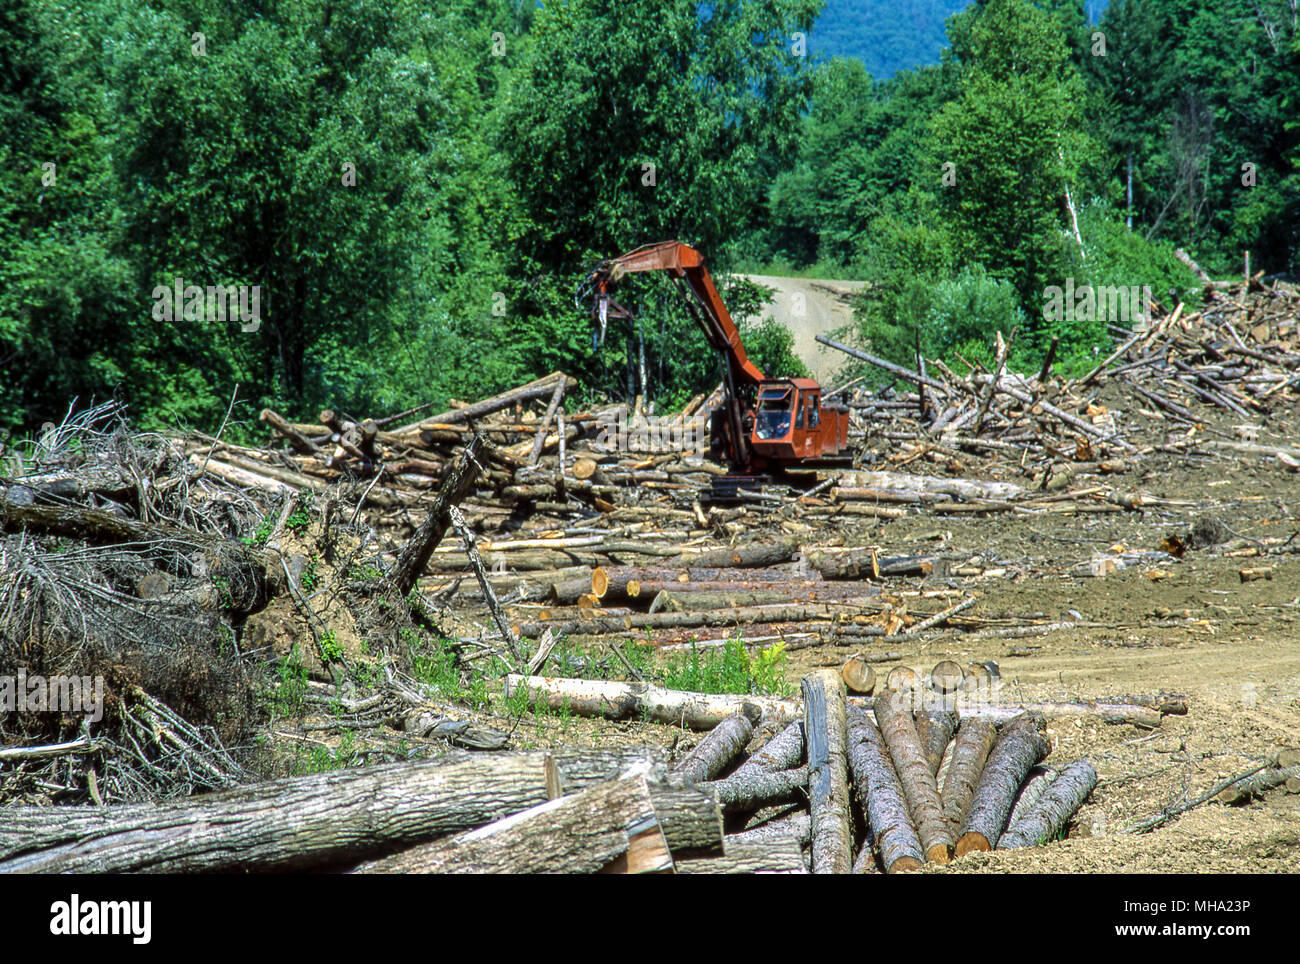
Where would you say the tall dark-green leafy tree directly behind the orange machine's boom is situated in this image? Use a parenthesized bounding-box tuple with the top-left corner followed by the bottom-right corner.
(499, 0, 819, 405)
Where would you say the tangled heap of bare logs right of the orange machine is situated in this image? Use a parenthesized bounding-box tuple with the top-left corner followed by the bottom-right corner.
(818, 275, 1300, 485)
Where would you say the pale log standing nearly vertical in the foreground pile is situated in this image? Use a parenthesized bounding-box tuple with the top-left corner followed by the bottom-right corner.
(801, 669, 853, 873)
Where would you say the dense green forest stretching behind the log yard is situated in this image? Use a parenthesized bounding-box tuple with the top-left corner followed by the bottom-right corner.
(0, 0, 1300, 439)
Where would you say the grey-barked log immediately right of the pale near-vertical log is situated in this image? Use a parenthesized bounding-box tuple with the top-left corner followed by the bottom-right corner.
(849, 708, 924, 873)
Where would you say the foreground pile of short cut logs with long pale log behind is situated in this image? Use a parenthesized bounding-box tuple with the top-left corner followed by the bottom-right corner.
(501, 670, 1097, 873)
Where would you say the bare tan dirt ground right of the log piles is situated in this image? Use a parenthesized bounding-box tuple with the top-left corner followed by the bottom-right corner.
(496, 456, 1300, 873)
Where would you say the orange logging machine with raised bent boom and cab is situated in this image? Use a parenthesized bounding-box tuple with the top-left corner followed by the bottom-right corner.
(575, 242, 850, 496)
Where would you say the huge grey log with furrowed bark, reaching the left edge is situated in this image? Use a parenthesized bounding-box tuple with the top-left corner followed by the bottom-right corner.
(0, 752, 554, 873)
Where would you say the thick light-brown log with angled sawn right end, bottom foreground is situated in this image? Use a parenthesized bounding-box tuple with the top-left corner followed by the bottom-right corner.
(356, 774, 672, 873)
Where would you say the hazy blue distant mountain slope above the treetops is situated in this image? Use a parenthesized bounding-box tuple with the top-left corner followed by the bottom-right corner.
(809, 0, 967, 81)
